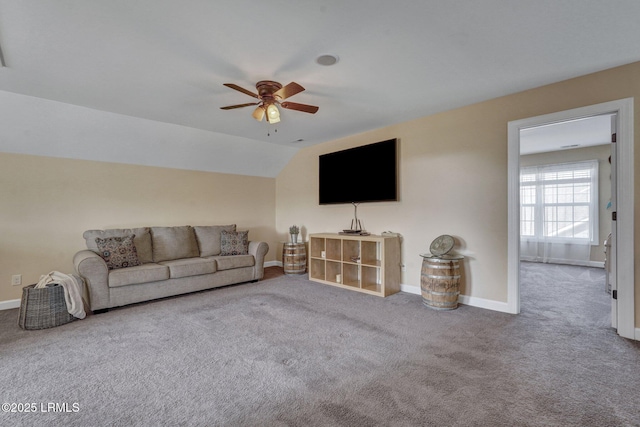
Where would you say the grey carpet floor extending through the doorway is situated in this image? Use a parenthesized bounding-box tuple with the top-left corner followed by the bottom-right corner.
(0, 263, 640, 426)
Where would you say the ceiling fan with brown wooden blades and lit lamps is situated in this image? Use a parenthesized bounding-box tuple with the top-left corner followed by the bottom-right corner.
(220, 80, 318, 124)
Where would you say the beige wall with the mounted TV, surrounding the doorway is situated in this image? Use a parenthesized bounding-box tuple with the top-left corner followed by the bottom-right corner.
(276, 63, 640, 324)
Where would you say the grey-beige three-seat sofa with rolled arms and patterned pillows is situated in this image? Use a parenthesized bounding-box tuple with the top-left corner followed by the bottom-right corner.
(73, 224, 269, 311)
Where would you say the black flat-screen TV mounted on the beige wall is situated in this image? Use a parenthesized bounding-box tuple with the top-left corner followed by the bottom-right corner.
(319, 139, 398, 205)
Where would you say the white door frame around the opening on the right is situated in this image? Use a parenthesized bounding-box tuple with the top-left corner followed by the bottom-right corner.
(507, 98, 640, 340)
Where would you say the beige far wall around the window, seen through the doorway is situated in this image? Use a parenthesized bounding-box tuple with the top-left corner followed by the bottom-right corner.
(520, 145, 611, 262)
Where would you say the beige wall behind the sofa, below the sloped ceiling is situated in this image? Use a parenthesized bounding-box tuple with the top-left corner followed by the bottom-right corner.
(0, 153, 277, 302)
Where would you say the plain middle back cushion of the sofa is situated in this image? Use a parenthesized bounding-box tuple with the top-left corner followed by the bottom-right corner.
(151, 225, 199, 262)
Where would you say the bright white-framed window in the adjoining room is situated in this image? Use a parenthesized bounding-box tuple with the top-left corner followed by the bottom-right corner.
(520, 160, 598, 244)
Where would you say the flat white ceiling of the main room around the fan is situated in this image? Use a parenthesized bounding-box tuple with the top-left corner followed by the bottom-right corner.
(0, 0, 640, 173)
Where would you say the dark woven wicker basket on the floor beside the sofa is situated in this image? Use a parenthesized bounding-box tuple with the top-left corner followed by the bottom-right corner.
(18, 284, 75, 330)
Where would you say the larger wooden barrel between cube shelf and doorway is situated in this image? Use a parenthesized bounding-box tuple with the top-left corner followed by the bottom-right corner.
(420, 255, 463, 310)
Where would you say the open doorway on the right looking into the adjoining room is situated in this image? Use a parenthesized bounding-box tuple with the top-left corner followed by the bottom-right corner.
(519, 114, 617, 324)
